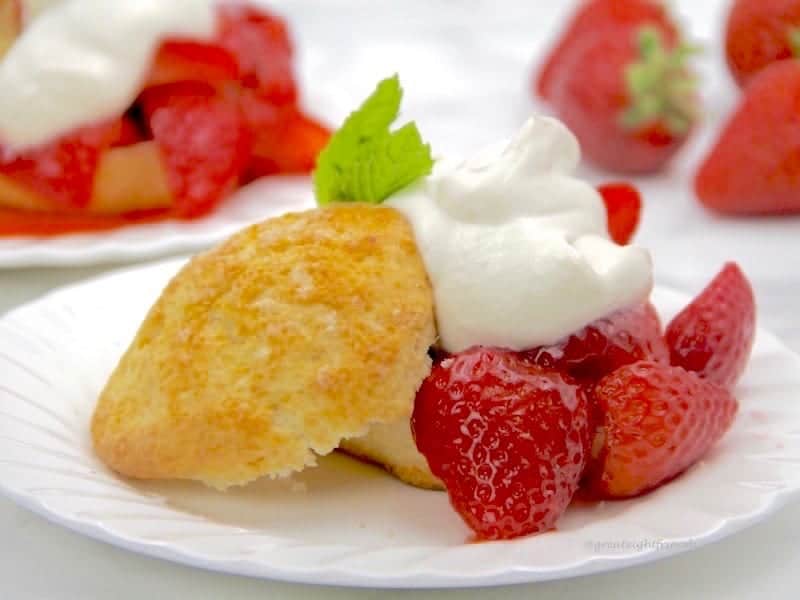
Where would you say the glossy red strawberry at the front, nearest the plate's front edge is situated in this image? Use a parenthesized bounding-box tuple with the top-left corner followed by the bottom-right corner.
(411, 348, 589, 540)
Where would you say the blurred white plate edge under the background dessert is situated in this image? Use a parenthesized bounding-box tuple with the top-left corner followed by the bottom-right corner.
(0, 176, 314, 269)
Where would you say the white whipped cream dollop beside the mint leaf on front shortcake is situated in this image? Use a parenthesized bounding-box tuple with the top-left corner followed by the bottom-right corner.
(387, 117, 653, 352)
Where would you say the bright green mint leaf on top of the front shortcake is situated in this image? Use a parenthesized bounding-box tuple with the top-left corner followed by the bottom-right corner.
(314, 75, 433, 206)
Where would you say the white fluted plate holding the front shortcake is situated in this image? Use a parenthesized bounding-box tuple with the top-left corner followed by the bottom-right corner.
(0, 261, 800, 587)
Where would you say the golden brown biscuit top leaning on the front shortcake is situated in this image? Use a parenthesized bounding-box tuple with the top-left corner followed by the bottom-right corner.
(92, 204, 435, 488)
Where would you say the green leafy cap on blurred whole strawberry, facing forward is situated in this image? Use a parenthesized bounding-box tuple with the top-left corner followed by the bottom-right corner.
(621, 27, 698, 135)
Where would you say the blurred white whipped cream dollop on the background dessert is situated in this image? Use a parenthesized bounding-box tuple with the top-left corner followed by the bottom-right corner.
(0, 0, 216, 151)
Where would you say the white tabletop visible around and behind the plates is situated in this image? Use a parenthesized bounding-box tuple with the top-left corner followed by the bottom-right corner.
(0, 0, 800, 600)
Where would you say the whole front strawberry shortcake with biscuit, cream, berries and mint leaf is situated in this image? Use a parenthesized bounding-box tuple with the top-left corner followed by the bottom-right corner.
(91, 78, 755, 540)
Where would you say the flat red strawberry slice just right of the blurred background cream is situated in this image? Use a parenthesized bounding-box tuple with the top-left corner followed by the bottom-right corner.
(144, 40, 239, 88)
